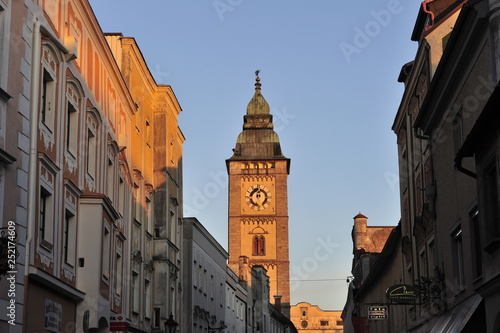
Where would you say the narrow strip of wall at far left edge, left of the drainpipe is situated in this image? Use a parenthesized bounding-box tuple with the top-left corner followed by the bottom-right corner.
(0, 1, 31, 332)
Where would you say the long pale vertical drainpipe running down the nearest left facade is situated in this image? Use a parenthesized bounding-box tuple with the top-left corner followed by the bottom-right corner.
(24, 17, 42, 277)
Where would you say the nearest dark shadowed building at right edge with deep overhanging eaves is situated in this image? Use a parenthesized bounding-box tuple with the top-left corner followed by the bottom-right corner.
(414, 1, 500, 332)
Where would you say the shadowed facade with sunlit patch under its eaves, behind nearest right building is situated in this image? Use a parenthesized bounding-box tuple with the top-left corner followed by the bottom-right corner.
(393, 4, 471, 329)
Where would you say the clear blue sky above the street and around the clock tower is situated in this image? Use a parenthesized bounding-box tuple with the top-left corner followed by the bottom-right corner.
(90, 0, 420, 310)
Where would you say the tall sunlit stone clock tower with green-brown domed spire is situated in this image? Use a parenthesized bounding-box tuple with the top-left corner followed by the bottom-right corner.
(226, 71, 290, 316)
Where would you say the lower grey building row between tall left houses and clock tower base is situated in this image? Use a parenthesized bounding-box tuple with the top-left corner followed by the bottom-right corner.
(185, 217, 296, 333)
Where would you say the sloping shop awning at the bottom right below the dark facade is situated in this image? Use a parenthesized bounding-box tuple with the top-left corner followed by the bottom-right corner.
(431, 294, 482, 333)
